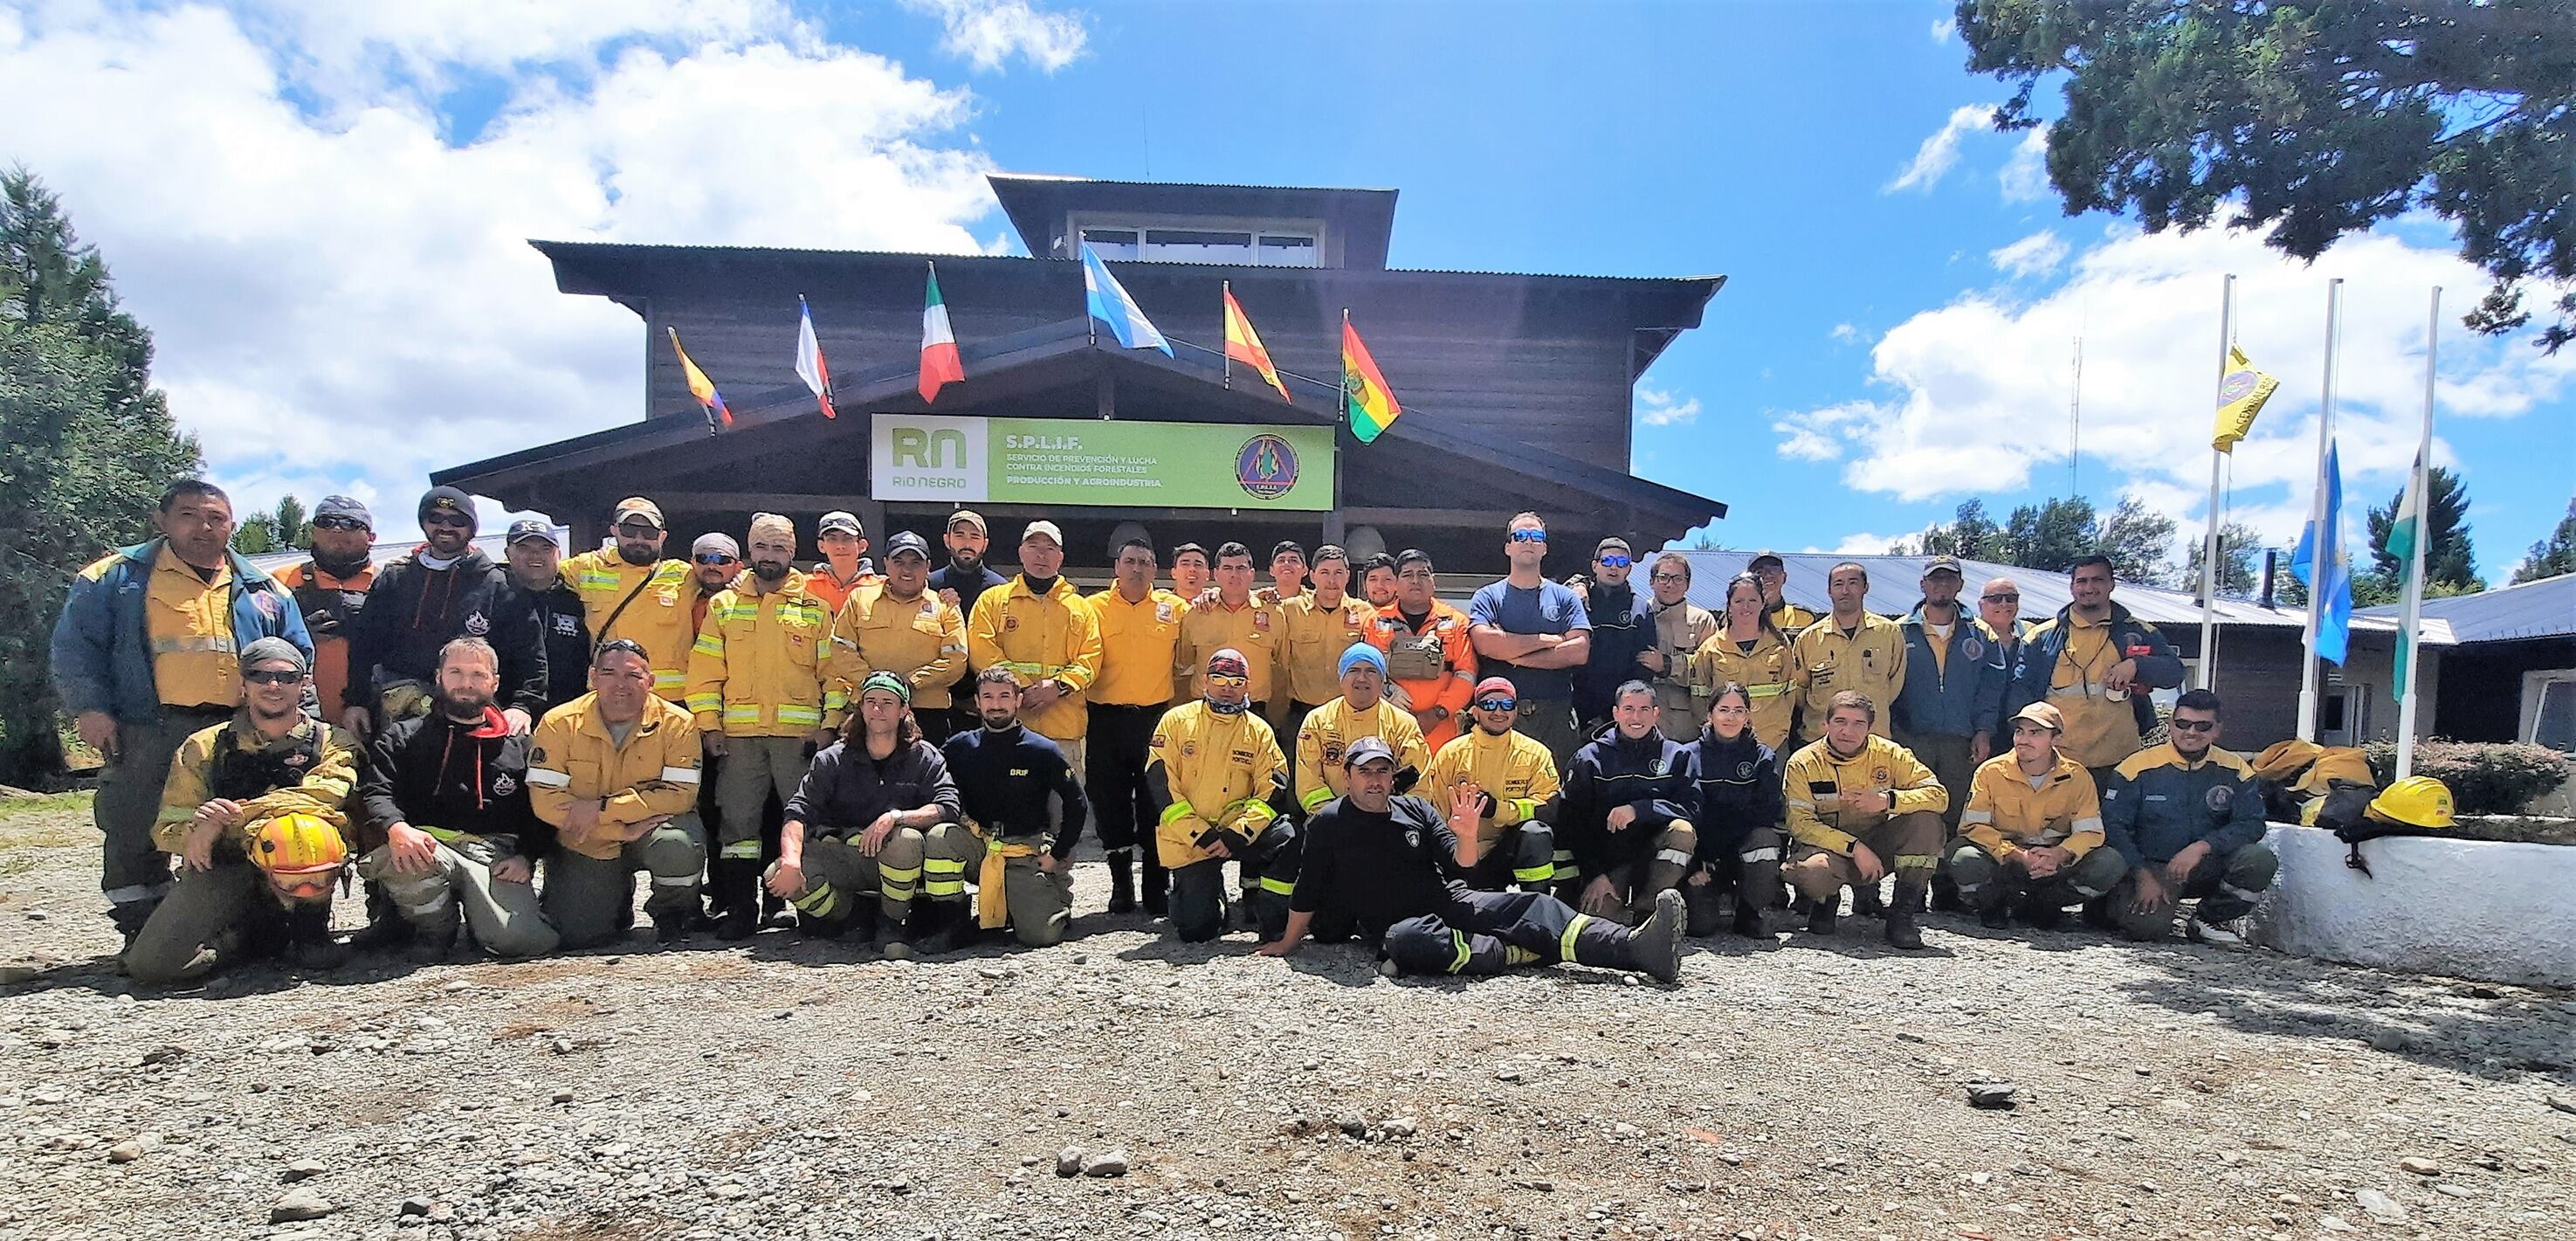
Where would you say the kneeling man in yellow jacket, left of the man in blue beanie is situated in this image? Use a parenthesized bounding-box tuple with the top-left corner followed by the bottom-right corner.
(1144, 646, 1301, 942)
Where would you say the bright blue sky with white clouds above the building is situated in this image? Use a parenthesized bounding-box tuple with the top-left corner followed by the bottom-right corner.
(0, 0, 2576, 584)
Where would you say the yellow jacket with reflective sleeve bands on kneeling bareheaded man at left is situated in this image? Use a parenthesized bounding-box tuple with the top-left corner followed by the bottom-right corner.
(528, 693, 698, 860)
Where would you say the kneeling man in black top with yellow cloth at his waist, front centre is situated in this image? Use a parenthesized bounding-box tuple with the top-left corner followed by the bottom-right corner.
(922, 667, 1082, 953)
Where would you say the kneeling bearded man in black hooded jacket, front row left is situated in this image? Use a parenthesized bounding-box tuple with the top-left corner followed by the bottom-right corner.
(358, 641, 556, 963)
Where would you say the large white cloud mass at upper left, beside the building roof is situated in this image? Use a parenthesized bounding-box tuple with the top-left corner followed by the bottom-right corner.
(0, 0, 1025, 533)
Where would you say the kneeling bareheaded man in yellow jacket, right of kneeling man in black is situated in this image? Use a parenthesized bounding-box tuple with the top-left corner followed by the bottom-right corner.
(528, 638, 706, 948)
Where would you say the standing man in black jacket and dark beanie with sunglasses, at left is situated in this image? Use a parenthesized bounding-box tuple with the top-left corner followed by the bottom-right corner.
(342, 486, 546, 736)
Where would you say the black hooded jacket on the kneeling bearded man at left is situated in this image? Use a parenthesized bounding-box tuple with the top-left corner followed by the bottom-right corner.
(358, 708, 554, 858)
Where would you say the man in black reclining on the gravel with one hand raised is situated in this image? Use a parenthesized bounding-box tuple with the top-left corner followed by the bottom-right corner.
(1260, 736, 1684, 983)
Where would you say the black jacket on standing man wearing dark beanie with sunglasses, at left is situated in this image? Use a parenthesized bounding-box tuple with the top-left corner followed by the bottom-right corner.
(348, 548, 546, 716)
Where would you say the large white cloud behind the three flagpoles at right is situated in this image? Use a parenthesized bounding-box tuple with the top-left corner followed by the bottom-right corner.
(1773, 226, 2576, 541)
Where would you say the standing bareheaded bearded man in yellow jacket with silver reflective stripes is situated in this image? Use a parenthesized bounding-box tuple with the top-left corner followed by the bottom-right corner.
(688, 513, 851, 940)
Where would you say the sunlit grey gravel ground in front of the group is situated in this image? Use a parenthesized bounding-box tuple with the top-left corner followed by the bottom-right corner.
(0, 803, 2576, 1241)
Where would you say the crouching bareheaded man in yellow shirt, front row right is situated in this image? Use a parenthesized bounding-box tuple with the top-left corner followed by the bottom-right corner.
(1780, 690, 1950, 948)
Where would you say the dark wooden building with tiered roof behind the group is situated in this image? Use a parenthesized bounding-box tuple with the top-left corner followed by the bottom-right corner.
(436, 175, 1726, 574)
